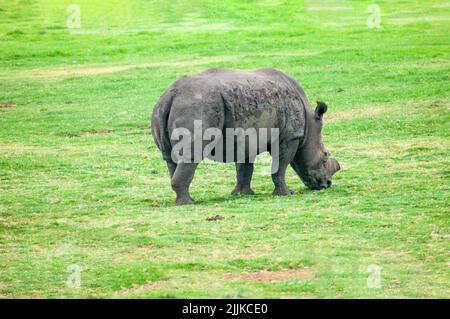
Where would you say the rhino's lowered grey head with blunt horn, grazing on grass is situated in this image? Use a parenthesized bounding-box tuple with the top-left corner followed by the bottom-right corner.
(290, 102, 341, 189)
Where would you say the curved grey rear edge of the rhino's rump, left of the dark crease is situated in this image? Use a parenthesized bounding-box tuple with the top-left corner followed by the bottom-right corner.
(151, 89, 175, 160)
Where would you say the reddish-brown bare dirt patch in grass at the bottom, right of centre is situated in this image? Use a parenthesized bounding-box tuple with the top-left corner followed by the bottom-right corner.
(239, 268, 314, 282)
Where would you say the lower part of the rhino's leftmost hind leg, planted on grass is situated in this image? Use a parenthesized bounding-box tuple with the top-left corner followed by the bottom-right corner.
(171, 163, 198, 205)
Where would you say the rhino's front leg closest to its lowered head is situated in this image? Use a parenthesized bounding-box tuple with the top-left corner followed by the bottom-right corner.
(272, 139, 299, 196)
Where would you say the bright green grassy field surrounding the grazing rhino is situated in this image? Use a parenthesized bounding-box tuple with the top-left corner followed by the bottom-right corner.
(0, 0, 450, 298)
